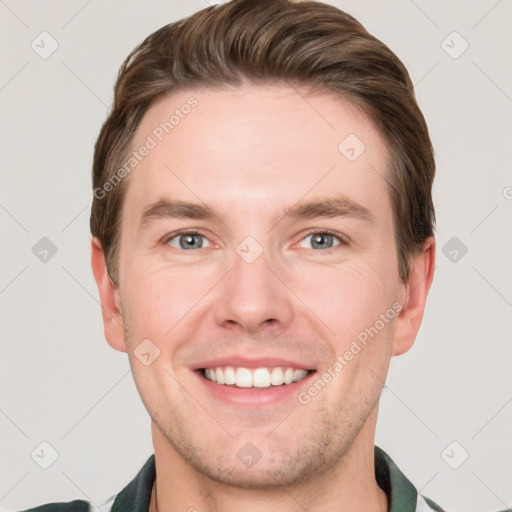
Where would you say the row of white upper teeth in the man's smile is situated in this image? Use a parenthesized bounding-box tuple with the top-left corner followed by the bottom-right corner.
(204, 366, 308, 388)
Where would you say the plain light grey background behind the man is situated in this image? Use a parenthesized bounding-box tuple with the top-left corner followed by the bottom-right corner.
(0, 0, 512, 512)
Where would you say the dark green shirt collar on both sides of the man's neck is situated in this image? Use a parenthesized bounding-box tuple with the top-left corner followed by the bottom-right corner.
(111, 446, 440, 512)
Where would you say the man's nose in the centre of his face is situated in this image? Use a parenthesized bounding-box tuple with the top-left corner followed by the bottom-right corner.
(215, 244, 293, 334)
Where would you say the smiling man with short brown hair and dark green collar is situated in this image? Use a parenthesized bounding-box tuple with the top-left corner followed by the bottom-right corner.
(21, 0, 452, 512)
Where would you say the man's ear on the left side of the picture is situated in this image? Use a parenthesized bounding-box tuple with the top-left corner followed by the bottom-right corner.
(91, 237, 126, 352)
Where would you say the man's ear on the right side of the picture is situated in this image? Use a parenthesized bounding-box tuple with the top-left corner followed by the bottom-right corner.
(392, 237, 436, 356)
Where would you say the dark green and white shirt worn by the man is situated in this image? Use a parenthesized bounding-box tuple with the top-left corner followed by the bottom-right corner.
(15, 446, 443, 512)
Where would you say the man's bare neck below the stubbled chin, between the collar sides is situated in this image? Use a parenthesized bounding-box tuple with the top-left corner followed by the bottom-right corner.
(150, 417, 388, 512)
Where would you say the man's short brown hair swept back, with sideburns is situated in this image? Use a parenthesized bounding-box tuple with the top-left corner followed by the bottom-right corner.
(91, 0, 435, 285)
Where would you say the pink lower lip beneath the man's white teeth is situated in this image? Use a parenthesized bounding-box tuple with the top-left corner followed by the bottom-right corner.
(194, 371, 315, 406)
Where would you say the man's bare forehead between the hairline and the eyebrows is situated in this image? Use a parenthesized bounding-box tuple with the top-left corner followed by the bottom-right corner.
(125, 85, 388, 220)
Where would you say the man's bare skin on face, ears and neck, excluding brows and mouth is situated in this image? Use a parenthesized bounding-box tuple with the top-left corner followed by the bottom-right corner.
(92, 84, 435, 512)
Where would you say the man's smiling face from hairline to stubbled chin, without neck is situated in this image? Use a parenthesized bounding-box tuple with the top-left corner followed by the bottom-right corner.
(93, 86, 432, 486)
